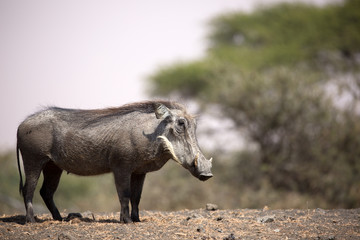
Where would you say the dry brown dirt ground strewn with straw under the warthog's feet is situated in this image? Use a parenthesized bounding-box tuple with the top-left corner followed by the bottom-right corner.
(0, 209, 360, 240)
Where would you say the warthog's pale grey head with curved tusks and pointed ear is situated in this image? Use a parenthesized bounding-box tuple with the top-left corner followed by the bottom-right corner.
(155, 104, 213, 181)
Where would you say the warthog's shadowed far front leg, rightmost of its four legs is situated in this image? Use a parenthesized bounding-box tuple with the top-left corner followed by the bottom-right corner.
(130, 173, 145, 222)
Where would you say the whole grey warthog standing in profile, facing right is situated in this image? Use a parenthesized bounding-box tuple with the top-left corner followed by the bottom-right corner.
(17, 101, 212, 223)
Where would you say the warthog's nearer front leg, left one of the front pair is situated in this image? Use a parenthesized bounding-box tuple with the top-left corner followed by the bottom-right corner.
(114, 171, 132, 223)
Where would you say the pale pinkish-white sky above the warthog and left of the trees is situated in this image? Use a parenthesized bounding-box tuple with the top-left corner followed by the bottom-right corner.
(0, 0, 329, 149)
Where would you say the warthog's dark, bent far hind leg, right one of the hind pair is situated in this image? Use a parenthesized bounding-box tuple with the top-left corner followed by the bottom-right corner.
(40, 161, 62, 221)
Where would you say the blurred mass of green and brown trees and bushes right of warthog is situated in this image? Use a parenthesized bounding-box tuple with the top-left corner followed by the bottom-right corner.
(150, 0, 360, 207)
